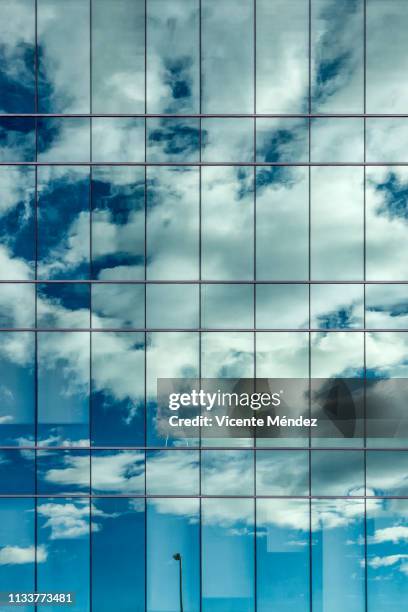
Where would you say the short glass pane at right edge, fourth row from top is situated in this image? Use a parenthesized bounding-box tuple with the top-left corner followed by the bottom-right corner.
(366, 283, 408, 329)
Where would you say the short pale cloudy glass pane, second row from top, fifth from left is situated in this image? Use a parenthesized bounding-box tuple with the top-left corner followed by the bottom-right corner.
(201, 119, 254, 163)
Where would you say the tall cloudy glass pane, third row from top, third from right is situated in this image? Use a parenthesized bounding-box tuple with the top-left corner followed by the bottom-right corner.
(256, 166, 309, 281)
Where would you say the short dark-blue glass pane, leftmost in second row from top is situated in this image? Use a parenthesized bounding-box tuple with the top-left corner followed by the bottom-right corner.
(0, 117, 36, 163)
